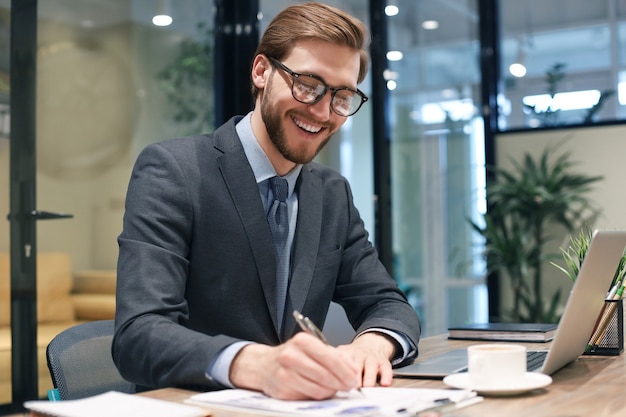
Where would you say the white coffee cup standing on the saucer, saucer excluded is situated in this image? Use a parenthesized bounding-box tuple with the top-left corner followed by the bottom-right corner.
(467, 343, 526, 388)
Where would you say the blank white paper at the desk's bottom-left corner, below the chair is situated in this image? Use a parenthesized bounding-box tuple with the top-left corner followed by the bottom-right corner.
(24, 391, 211, 417)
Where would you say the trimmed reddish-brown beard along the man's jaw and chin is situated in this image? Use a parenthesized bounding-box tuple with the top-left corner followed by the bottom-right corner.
(261, 79, 332, 164)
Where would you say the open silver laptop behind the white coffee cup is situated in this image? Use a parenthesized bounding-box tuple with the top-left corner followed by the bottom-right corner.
(394, 230, 626, 378)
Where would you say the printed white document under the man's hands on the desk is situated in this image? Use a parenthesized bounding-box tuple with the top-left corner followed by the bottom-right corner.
(187, 387, 482, 417)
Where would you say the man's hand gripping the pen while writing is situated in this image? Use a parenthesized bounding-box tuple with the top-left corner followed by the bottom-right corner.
(230, 332, 358, 400)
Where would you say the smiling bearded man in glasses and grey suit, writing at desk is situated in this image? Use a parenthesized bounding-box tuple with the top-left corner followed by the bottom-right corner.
(113, 3, 420, 399)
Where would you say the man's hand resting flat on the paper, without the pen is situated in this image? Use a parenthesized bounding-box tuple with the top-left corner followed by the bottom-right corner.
(338, 332, 396, 387)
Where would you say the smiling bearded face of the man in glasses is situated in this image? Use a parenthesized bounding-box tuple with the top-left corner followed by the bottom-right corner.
(255, 40, 359, 165)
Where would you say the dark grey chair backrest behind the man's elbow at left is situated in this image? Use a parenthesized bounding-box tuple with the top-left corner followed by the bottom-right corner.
(46, 320, 136, 400)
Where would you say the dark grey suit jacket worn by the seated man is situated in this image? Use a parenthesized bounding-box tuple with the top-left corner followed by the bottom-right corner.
(112, 118, 420, 389)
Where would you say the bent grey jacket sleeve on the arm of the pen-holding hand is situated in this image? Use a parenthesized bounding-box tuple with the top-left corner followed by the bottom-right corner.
(112, 144, 238, 388)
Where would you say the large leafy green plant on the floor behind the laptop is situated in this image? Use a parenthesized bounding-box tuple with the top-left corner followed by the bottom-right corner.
(469, 147, 602, 323)
